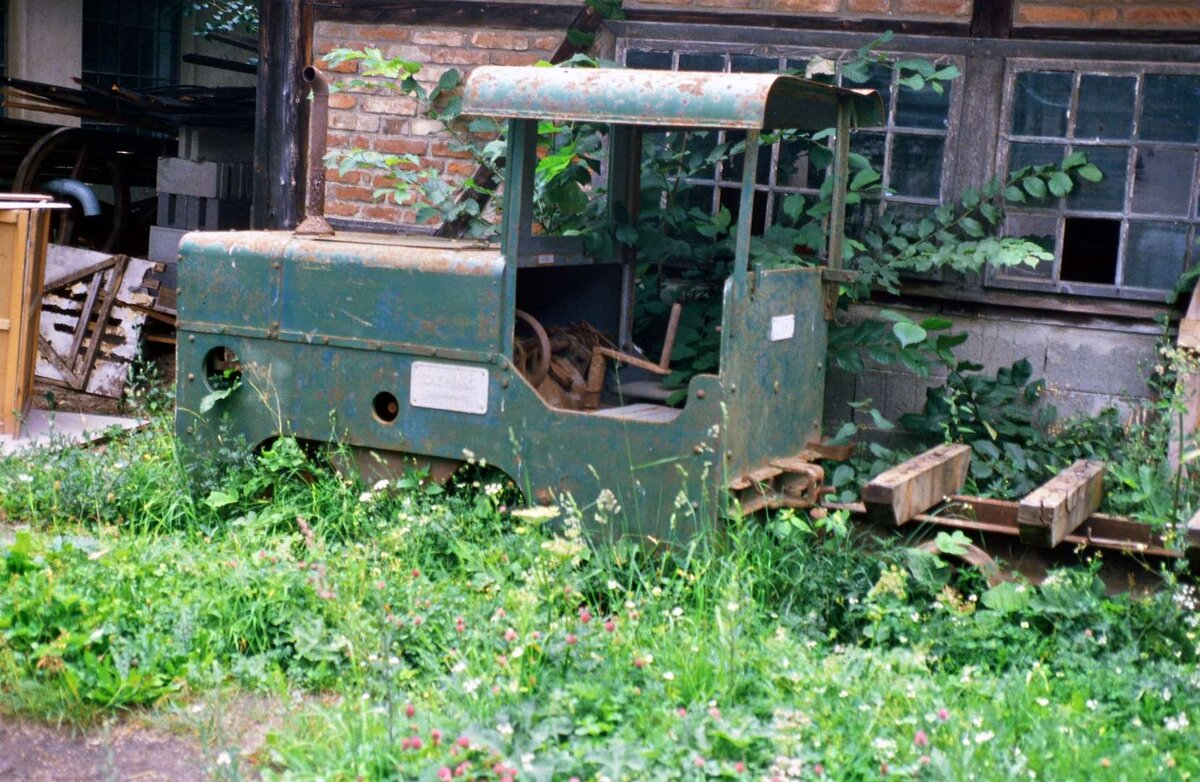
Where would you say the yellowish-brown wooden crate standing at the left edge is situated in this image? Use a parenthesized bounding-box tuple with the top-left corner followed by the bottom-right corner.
(0, 205, 50, 437)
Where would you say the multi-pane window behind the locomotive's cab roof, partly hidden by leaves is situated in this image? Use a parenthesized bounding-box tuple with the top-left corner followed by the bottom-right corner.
(624, 46, 962, 233)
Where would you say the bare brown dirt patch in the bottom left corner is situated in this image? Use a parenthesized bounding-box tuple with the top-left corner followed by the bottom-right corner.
(0, 715, 209, 782)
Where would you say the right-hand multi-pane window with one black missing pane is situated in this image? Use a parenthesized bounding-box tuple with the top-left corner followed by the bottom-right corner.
(990, 61, 1200, 299)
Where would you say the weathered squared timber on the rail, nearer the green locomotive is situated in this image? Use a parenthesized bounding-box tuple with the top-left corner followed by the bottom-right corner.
(863, 445, 971, 527)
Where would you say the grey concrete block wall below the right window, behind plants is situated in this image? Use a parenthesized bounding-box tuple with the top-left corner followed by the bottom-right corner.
(826, 305, 1160, 432)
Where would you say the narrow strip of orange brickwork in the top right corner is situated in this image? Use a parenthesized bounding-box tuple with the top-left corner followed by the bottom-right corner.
(1013, 0, 1200, 30)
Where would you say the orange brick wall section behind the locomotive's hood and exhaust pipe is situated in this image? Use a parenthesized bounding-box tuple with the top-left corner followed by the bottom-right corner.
(313, 22, 562, 223)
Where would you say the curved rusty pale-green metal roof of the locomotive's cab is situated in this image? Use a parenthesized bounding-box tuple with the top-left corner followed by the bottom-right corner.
(463, 66, 883, 131)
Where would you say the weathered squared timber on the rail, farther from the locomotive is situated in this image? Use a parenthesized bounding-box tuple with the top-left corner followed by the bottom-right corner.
(1016, 459, 1104, 548)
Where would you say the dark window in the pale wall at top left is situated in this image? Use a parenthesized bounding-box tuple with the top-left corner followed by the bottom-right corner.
(83, 0, 180, 90)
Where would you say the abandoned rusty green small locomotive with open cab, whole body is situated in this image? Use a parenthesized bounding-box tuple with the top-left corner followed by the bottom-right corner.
(176, 67, 882, 540)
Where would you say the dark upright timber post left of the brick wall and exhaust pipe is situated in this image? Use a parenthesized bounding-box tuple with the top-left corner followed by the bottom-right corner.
(252, 0, 308, 229)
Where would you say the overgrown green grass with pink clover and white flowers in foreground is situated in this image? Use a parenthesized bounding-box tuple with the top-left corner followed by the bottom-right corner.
(0, 421, 1200, 780)
